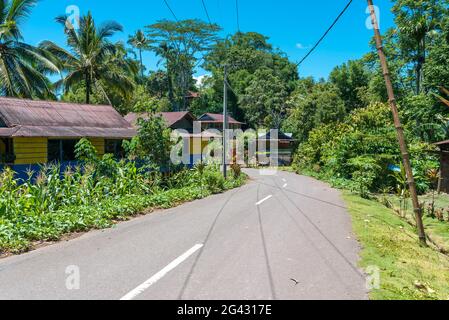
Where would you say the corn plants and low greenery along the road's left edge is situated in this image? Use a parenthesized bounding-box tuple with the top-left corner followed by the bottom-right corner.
(0, 149, 245, 255)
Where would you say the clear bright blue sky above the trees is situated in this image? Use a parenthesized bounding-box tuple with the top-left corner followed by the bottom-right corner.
(23, 0, 393, 78)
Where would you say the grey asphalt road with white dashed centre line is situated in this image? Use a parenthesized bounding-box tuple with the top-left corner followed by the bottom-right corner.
(0, 170, 367, 300)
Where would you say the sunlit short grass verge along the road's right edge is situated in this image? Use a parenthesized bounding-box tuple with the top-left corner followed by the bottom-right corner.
(343, 191, 449, 300)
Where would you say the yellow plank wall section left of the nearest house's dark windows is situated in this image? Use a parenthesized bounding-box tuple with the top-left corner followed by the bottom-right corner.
(13, 138, 48, 164)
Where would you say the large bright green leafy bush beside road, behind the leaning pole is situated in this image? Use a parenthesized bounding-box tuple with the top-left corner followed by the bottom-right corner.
(293, 103, 438, 192)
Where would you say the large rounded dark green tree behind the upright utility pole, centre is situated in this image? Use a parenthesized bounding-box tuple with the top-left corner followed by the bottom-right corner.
(201, 32, 298, 128)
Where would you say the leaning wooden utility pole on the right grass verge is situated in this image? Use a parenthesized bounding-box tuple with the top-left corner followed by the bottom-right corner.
(368, 0, 426, 245)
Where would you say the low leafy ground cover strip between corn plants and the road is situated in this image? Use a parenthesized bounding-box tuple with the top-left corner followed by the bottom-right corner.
(0, 173, 247, 257)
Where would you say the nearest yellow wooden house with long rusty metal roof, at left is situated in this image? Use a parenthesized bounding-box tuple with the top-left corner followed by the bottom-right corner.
(0, 97, 136, 171)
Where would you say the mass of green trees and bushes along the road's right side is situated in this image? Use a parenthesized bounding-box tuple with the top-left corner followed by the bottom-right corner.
(283, 0, 449, 196)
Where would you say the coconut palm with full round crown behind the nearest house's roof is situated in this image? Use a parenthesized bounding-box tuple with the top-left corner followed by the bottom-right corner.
(39, 12, 134, 103)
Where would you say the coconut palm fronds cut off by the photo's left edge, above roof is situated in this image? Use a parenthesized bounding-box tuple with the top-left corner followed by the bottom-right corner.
(0, 0, 58, 98)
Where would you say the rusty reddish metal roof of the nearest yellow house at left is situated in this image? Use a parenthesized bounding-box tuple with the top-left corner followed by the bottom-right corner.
(0, 97, 136, 138)
